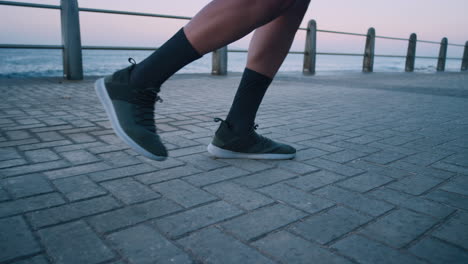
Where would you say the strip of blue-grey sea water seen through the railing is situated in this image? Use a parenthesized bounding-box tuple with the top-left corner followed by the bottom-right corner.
(0, 49, 461, 78)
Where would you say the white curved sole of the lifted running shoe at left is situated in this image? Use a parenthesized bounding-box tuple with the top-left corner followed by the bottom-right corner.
(94, 78, 167, 161)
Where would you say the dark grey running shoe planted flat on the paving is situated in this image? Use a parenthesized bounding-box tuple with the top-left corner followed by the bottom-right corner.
(208, 118, 296, 159)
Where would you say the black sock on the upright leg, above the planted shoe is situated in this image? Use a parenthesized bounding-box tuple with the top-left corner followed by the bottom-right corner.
(226, 68, 272, 134)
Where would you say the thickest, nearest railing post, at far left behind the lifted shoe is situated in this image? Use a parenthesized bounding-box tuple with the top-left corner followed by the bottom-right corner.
(60, 0, 83, 80)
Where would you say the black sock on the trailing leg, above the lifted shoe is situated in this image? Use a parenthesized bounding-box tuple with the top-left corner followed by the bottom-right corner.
(130, 29, 202, 88)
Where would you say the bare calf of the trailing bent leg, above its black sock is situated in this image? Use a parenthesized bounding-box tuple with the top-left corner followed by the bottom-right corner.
(184, 0, 296, 55)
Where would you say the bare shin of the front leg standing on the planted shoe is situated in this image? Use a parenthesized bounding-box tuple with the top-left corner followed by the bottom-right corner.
(247, 0, 310, 78)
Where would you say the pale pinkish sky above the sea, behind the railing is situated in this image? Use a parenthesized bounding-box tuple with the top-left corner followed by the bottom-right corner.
(0, 0, 468, 57)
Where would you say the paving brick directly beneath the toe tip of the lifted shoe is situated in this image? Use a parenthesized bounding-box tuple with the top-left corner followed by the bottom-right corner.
(135, 165, 202, 185)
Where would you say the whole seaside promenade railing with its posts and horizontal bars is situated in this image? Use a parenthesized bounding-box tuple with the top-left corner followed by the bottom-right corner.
(0, 0, 468, 80)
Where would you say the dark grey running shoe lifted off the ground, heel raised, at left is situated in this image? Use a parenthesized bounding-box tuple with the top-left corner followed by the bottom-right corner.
(94, 58, 167, 161)
